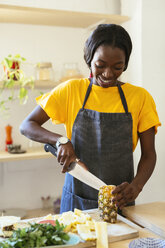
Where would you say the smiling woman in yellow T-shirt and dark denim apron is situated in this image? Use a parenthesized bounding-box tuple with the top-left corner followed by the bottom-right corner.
(20, 24, 160, 213)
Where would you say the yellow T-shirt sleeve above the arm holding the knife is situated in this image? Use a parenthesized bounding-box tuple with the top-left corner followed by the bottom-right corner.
(36, 82, 68, 124)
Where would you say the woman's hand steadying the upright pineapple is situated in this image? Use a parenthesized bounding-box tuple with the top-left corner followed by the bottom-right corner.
(113, 182, 141, 209)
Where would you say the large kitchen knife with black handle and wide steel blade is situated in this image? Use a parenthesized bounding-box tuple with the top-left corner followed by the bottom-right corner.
(44, 144, 106, 190)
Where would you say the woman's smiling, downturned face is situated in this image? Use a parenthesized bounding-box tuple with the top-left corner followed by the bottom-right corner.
(91, 45, 125, 88)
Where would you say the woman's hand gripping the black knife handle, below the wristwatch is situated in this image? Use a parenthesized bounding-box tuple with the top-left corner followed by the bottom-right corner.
(57, 142, 88, 173)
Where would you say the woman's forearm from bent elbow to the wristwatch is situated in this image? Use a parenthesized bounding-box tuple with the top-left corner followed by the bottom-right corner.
(20, 121, 61, 144)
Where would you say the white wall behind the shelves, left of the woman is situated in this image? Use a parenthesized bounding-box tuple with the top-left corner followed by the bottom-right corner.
(0, 0, 120, 209)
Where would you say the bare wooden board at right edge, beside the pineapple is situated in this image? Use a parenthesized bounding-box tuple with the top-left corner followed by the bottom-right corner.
(123, 201, 165, 238)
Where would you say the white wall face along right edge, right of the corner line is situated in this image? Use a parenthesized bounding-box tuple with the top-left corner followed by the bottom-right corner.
(142, 0, 165, 201)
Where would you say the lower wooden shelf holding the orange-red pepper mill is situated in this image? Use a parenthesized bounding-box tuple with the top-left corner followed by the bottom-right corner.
(0, 148, 53, 162)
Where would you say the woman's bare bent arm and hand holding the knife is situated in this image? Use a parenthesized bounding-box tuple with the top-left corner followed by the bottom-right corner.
(20, 106, 87, 173)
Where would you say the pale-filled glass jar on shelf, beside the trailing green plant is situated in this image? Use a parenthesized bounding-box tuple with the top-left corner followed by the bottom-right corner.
(36, 62, 53, 81)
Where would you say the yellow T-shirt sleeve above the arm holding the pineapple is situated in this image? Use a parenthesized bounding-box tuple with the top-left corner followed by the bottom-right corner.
(138, 90, 161, 133)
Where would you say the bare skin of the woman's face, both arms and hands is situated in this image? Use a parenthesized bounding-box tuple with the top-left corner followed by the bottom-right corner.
(20, 45, 156, 209)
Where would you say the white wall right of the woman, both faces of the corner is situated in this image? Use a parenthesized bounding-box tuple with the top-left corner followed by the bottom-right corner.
(121, 0, 165, 203)
